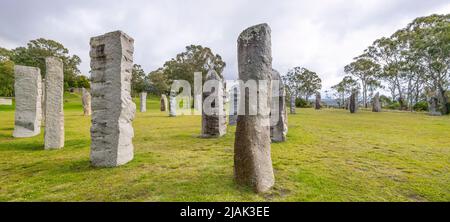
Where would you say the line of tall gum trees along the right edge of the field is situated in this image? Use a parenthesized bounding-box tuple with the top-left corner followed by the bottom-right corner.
(332, 14, 450, 114)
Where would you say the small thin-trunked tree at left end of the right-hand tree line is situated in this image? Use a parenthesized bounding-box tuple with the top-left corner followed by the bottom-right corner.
(344, 54, 380, 108)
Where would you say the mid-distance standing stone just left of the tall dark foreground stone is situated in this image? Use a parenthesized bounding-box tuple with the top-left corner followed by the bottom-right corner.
(202, 70, 227, 138)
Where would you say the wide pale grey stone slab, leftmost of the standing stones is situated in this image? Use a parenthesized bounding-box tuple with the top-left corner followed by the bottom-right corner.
(13, 65, 42, 138)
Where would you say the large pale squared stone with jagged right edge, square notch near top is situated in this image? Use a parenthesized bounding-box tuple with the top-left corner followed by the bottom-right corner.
(90, 31, 136, 167)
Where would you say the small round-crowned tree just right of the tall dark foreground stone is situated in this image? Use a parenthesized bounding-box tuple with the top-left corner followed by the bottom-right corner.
(282, 67, 322, 101)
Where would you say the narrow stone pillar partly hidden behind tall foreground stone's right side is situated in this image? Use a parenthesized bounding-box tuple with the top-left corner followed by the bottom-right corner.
(270, 70, 288, 142)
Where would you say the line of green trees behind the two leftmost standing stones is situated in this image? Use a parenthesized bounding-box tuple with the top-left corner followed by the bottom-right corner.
(0, 38, 90, 97)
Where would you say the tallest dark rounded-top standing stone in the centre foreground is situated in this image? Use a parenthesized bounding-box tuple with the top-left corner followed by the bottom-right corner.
(234, 24, 275, 192)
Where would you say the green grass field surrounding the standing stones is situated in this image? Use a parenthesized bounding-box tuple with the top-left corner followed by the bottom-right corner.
(0, 95, 450, 201)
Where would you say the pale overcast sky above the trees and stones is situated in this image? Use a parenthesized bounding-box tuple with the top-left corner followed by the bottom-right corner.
(0, 0, 450, 89)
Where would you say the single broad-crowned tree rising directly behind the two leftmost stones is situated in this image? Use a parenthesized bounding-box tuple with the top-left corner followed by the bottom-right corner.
(10, 38, 81, 87)
